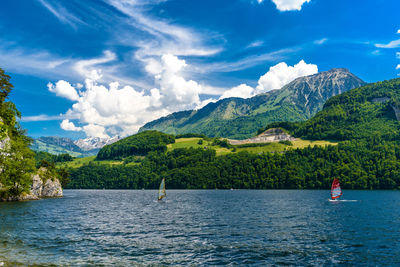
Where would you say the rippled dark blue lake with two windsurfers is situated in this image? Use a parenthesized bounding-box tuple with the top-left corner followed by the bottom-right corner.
(0, 190, 400, 266)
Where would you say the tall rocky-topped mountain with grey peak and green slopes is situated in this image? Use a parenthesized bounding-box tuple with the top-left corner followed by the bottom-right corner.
(139, 68, 365, 139)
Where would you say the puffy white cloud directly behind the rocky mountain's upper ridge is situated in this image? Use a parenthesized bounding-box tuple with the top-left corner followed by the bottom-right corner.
(257, 60, 318, 93)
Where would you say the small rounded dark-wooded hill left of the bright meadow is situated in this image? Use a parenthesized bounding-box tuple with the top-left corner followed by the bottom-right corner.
(97, 131, 175, 160)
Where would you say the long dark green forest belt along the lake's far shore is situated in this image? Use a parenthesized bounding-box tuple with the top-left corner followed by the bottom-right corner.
(68, 137, 400, 189)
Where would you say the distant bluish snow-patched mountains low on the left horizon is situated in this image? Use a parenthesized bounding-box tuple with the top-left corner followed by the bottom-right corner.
(31, 136, 120, 157)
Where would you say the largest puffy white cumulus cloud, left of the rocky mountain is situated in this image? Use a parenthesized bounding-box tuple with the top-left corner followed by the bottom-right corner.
(51, 54, 203, 137)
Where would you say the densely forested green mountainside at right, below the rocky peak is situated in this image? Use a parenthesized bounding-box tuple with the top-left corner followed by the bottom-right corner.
(274, 78, 400, 141)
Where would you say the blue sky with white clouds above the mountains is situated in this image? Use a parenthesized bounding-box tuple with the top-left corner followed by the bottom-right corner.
(0, 0, 400, 138)
